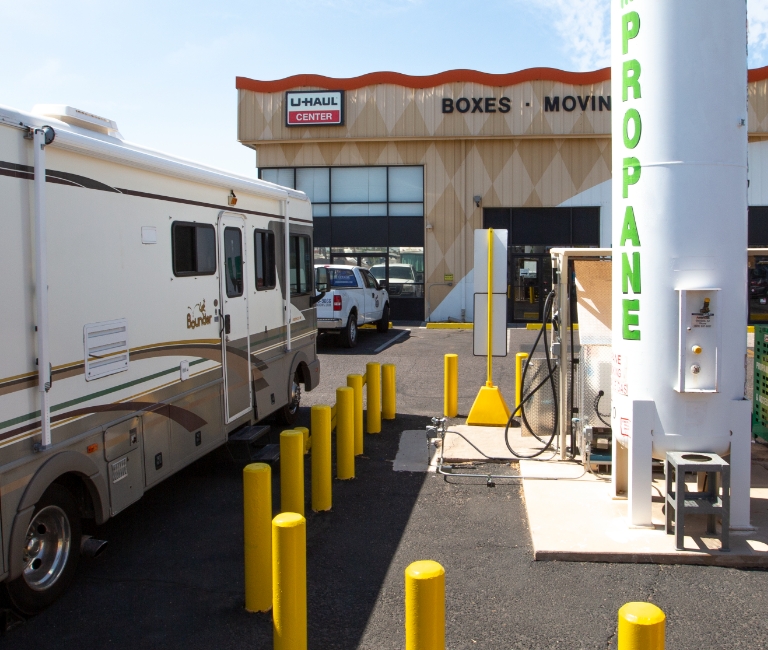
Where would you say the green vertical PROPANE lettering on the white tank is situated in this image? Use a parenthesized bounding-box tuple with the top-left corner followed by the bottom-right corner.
(619, 2, 643, 341)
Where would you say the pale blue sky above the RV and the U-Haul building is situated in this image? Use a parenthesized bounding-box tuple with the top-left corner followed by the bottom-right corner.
(0, 0, 768, 175)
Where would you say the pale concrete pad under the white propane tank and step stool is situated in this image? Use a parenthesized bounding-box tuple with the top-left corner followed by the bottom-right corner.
(520, 448, 768, 567)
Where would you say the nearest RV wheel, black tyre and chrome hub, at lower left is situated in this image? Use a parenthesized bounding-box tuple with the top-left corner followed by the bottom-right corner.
(7, 484, 81, 616)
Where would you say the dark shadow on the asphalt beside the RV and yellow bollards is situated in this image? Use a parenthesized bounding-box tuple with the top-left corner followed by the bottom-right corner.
(3, 408, 427, 650)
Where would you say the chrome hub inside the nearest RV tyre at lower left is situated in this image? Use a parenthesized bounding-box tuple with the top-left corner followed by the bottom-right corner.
(23, 506, 72, 591)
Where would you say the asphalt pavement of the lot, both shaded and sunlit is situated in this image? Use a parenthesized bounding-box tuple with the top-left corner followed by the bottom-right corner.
(0, 326, 768, 650)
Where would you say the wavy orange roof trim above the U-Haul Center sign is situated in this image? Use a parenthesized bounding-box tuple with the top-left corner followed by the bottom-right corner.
(235, 68, 611, 93)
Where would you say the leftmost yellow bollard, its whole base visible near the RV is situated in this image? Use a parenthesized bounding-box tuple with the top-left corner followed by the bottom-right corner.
(243, 463, 272, 612)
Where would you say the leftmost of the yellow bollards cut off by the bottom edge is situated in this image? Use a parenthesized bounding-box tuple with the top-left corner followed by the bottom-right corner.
(272, 512, 307, 650)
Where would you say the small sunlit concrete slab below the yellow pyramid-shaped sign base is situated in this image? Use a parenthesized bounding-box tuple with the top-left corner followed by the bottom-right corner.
(438, 424, 552, 463)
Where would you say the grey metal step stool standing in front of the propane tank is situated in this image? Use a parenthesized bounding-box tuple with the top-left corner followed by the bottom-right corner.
(664, 451, 731, 551)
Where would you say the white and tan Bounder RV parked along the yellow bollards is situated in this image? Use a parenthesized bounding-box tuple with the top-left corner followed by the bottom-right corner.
(0, 106, 320, 614)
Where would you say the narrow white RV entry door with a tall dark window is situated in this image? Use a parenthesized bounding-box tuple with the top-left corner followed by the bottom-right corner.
(219, 214, 252, 424)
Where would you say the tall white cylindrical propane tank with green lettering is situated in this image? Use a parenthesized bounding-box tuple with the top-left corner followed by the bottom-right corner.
(611, 0, 748, 458)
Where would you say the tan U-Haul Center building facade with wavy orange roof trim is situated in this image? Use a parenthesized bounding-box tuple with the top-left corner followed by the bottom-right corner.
(236, 67, 768, 323)
